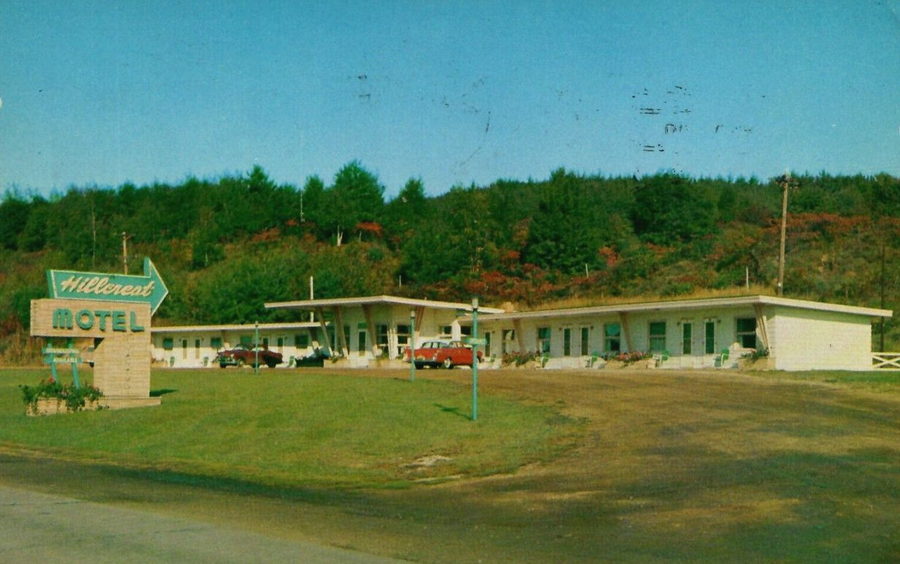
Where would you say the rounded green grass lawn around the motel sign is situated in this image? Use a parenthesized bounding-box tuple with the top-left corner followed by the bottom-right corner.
(0, 369, 577, 488)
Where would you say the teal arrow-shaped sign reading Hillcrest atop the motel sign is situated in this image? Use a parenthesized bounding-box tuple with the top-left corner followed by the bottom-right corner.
(47, 258, 169, 315)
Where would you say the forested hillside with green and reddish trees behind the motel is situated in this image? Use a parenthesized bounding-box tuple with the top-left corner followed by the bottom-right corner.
(0, 162, 900, 360)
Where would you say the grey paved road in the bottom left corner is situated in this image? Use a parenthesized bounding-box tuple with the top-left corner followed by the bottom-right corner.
(0, 486, 400, 563)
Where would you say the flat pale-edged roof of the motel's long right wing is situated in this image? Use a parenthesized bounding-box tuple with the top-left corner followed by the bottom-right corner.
(474, 296, 893, 321)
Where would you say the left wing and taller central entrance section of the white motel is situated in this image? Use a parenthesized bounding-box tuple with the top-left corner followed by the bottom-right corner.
(152, 296, 503, 368)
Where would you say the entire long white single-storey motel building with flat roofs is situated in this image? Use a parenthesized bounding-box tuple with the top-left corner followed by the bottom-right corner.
(151, 296, 897, 370)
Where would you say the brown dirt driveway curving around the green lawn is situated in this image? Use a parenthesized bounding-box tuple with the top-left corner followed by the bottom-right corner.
(0, 370, 900, 562)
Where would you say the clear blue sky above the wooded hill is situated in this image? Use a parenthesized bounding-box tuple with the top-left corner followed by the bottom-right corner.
(0, 0, 900, 198)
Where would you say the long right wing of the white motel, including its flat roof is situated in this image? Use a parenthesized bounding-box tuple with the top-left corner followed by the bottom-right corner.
(479, 296, 892, 370)
